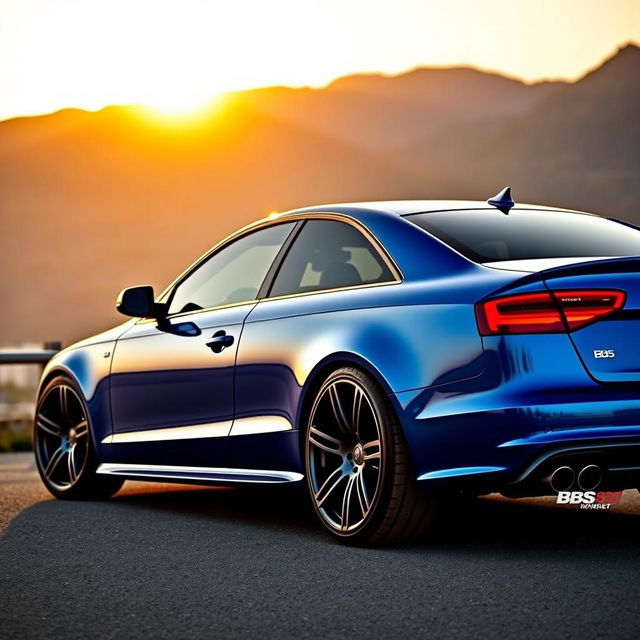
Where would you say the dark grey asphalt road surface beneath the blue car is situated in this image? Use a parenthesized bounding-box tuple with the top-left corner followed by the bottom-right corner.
(0, 454, 640, 640)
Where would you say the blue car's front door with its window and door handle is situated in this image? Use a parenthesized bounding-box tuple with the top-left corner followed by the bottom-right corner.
(108, 222, 295, 466)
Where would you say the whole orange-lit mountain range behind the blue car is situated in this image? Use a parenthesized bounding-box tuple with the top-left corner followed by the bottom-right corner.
(0, 46, 640, 345)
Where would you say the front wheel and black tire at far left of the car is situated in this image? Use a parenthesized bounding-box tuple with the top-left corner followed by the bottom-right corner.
(33, 375, 124, 500)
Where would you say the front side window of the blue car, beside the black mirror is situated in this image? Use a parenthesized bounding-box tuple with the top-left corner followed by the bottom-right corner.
(169, 222, 295, 314)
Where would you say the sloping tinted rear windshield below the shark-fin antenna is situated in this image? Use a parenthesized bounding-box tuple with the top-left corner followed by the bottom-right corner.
(406, 209, 640, 262)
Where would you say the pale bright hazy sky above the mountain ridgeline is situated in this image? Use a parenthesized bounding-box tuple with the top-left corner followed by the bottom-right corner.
(0, 0, 640, 119)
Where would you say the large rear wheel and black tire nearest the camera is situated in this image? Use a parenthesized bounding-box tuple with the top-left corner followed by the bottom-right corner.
(304, 367, 437, 545)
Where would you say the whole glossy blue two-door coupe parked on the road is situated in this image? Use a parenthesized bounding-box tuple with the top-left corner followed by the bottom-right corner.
(34, 189, 640, 544)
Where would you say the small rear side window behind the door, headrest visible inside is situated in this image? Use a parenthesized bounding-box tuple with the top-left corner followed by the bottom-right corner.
(269, 220, 393, 297)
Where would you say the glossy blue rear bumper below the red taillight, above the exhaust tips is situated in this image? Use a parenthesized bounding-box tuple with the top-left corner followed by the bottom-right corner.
(393, 334, 640, 495)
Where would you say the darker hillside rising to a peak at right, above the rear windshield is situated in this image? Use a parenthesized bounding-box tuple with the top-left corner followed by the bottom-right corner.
(396, 45, 640, 215)
